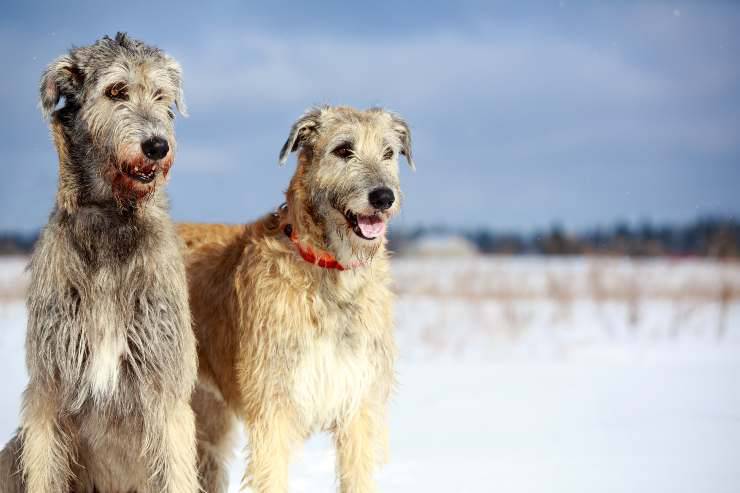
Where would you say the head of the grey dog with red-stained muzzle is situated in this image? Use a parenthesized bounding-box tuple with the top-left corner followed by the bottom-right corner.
(40, 33, 185, 204)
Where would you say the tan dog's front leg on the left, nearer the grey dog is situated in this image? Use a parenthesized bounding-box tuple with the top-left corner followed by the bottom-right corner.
(242, 411, 298, 493)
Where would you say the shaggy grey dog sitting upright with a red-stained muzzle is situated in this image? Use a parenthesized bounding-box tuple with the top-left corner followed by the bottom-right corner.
(0, 33, 198, 493)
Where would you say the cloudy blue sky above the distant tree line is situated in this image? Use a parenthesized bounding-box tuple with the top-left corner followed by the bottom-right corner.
(0, 0, 740, 230)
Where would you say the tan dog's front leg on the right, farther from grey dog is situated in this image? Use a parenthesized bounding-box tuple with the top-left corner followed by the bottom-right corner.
(334, 406, 385, 493)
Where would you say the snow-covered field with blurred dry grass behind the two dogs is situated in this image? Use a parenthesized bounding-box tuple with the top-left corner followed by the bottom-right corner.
(0, 257, 740, 493)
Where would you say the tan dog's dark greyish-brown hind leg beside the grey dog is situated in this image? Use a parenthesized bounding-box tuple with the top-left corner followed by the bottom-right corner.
(192, 382, 236, 493)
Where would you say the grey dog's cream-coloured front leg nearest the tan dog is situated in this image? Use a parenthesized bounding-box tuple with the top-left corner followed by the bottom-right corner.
(144, 401, 200, 493)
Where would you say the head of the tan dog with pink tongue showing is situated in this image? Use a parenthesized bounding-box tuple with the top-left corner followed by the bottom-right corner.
(280, 107, 414, 263)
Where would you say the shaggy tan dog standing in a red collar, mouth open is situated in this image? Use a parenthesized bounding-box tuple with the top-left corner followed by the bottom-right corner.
(179, 107, 413, 493)
